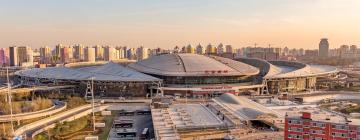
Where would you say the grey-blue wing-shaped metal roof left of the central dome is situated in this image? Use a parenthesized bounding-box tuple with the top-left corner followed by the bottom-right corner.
(15, 62, 161, 82)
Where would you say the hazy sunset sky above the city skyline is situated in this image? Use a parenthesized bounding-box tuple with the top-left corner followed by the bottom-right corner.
(0, 0, 360, 49)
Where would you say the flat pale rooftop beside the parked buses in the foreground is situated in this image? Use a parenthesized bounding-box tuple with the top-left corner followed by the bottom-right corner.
(151, 104, 224, 139)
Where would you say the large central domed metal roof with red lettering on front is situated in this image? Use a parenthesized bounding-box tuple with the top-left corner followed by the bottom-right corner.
(129, 53, 259, 76)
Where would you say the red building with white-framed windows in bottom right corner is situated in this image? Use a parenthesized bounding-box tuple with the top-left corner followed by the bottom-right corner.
(284, 112, 360, 140)
